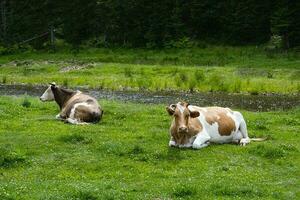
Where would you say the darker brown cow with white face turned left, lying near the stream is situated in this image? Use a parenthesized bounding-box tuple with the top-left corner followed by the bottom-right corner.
(40, 83, 103, 124)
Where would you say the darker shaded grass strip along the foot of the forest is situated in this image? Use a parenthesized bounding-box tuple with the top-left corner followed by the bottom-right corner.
(0, 45, 300, 68)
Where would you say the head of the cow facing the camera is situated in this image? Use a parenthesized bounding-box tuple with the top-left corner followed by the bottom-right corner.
(166, 102, 200, 134)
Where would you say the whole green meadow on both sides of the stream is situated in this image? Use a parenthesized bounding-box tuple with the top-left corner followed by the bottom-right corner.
(0, 46, 300, 200)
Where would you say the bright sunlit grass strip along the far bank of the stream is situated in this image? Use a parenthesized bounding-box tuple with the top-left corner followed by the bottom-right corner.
(0, 61, 300, 94)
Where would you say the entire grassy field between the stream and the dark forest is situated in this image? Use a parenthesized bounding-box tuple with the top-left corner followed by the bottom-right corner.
(0, 47, 300, 94)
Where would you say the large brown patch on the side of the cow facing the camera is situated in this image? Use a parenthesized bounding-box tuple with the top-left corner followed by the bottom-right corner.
(204, 107, 236, 136)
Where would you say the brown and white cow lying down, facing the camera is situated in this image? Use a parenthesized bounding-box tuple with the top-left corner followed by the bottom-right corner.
(166, 102, 264, 149)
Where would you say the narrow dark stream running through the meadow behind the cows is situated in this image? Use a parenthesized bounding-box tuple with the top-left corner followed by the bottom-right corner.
(0, 84, 300, 111)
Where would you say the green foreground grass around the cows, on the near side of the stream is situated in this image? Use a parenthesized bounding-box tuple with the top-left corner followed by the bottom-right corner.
(0, 96, 300, 199)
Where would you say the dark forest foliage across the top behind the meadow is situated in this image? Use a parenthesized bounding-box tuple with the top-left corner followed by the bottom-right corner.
(0, 0, 300, 49)
